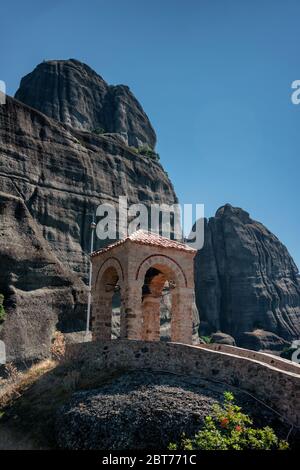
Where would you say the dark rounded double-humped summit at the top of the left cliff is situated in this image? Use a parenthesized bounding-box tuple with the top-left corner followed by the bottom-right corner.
(15, 59, 156, 148)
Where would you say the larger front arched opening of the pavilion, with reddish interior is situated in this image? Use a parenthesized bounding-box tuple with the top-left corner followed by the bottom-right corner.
(142, 264, 176, 341)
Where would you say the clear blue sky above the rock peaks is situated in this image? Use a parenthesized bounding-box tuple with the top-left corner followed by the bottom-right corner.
(0, 0, 300, 266)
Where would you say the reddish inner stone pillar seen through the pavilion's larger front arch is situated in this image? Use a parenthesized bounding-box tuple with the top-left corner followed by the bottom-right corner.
(142, 294, 160, 341)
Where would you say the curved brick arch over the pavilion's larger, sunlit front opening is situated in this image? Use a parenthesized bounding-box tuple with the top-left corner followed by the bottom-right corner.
(135, 253, 187, 287)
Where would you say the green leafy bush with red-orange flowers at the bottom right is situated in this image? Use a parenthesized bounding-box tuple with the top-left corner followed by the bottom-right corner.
(168, 392, 289, 450)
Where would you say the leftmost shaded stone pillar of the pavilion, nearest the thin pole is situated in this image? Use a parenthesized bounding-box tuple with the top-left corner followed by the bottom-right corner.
(92, 292, 113, 340)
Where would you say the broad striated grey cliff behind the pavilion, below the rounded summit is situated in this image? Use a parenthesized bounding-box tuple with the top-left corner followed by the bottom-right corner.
(0, 93, 177, 277)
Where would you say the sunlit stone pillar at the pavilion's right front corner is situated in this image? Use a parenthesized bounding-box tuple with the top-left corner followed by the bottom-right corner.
(171, 287, 194, 344)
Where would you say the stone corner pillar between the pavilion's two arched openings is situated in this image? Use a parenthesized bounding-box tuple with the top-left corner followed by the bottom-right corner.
(121, 281, 142, 340)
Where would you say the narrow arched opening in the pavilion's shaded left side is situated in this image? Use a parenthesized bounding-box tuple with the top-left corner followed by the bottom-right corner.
(93, 266, 121, 339)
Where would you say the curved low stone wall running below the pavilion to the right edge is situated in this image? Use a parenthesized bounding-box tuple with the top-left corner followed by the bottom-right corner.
(66, 340, 300, 426)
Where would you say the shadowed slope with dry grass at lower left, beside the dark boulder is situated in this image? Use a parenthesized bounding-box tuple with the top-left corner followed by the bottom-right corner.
(0, 360, 123, 449)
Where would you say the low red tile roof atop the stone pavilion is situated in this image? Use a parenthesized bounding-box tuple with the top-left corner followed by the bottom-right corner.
(91, 230, 197, 257)
